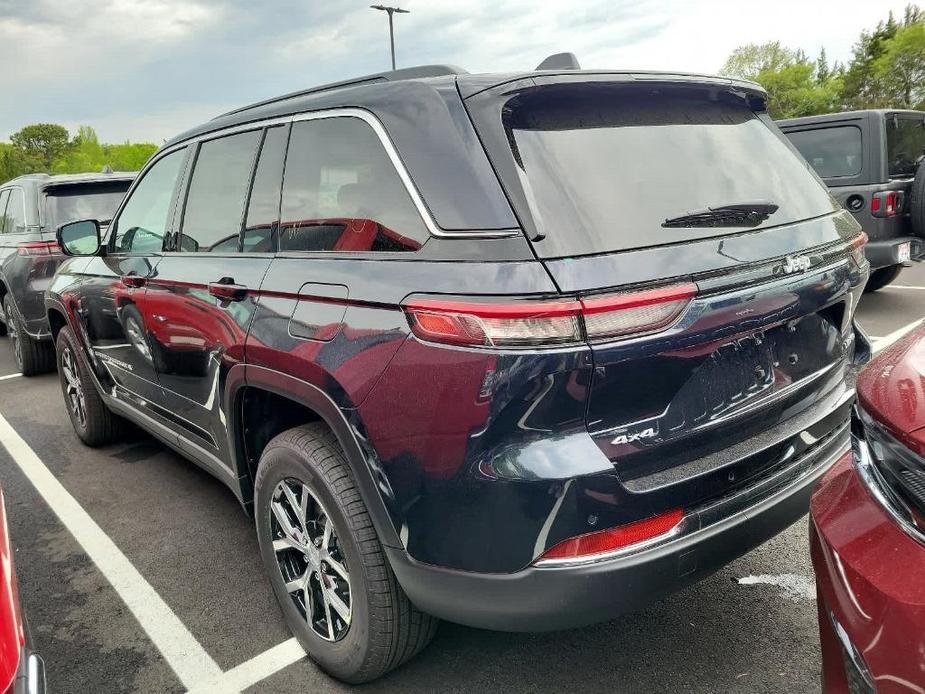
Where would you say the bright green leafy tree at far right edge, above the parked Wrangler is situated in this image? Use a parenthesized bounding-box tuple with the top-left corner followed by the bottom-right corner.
(871, 21, 925, 108)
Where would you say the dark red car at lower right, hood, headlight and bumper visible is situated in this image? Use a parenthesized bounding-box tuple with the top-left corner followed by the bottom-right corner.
(810, 324, 925, 694)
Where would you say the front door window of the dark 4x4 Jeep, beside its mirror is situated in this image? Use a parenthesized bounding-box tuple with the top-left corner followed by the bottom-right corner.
(113, 149, 186, 253)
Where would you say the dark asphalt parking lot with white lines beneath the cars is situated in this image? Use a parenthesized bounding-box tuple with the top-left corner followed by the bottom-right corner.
(0, 265, 925, 692)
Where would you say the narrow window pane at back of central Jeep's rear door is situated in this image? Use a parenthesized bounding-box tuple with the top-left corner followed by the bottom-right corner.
(243, 126, 288, 253)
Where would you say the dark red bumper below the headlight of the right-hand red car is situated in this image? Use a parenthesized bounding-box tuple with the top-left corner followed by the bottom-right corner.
(810, 441, 925, 694)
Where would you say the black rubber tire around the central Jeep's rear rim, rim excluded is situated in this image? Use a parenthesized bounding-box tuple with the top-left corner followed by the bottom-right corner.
(254, 423, 438, 684)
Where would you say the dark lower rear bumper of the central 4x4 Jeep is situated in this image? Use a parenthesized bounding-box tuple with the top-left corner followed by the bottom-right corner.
(386, 416, 848, 631)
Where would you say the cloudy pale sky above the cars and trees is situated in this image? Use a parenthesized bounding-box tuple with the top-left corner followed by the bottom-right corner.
(0, 0, 907, 144)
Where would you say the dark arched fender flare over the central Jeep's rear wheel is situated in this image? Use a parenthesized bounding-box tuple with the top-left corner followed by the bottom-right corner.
(225, 364, 403, 549)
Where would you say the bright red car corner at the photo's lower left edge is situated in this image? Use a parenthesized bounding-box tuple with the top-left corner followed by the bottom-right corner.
(0, 490, 45, 694)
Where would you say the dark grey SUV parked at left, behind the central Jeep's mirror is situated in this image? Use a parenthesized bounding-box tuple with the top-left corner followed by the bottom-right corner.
(0, 173, 135, 376)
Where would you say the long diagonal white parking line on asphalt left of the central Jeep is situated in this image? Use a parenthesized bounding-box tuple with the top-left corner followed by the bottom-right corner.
(0, 415, 220, 692)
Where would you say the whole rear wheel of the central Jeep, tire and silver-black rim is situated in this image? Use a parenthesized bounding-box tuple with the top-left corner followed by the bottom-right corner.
(254, 423, 438, 684)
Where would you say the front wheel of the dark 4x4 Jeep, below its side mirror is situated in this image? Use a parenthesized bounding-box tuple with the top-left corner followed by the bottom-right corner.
(55, 327, 125, 447)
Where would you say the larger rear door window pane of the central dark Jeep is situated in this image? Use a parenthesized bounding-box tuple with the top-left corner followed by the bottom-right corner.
(180, 130, 261, 253)
